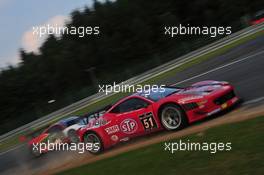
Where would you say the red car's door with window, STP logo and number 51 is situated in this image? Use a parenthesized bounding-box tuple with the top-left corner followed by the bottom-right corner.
(111, 97, 157, 138)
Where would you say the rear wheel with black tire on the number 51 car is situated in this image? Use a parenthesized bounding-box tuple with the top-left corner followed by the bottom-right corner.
(83, 132, 104, 154)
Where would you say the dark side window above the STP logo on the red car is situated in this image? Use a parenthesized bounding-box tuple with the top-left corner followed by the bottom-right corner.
(111, 98, 148, 113)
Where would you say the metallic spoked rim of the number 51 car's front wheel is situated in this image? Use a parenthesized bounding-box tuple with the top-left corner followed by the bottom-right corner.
(161, 107, 181, 130)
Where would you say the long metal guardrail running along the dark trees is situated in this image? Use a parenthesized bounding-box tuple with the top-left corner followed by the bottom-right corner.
(0, 24, 264, 142)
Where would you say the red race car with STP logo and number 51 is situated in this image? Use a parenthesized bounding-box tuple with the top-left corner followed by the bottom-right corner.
(77, 81, 239, 154)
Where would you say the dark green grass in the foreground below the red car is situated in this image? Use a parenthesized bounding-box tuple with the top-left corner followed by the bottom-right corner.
(59, 117, 264, 175)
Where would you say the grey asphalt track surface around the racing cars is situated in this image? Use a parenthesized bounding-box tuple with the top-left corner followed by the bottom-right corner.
(0, 36, 264, 174)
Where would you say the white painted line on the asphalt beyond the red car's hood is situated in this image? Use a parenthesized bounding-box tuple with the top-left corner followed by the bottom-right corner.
(172, 51, 264, 86)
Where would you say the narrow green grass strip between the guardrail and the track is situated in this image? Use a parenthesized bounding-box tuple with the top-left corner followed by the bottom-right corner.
(0, 31, 264, 152)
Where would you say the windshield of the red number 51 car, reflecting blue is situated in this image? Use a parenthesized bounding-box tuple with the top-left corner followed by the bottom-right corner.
(137, 87, 181, 101)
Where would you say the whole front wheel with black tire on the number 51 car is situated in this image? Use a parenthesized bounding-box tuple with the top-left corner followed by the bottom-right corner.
(159, 104, 188, 130)
